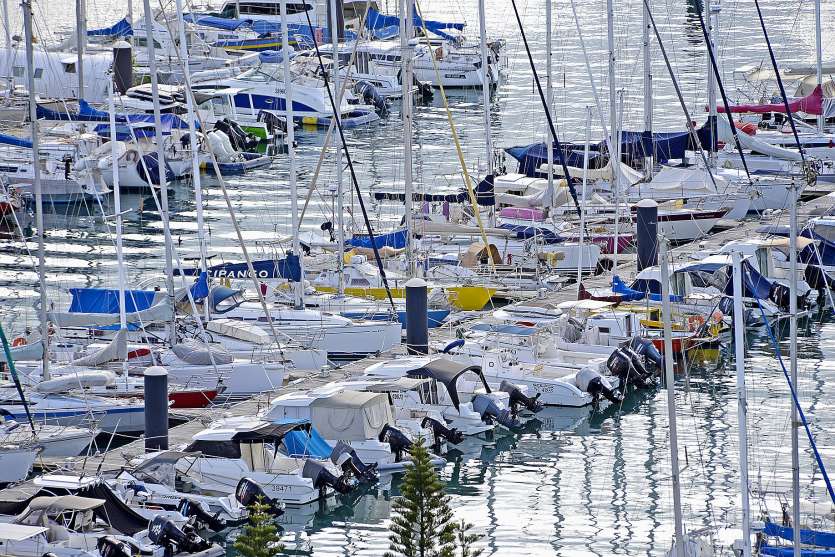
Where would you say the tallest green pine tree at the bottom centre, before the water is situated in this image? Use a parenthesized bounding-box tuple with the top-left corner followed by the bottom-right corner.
(385, 439, 455, 557)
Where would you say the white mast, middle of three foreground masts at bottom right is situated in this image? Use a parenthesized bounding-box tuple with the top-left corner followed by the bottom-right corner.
(731, 251, 751, 557)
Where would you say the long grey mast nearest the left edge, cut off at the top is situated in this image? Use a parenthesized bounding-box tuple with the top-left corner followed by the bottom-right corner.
(22, 0, 49, 380)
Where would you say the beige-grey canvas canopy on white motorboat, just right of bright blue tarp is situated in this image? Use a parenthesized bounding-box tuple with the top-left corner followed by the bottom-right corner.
(310, 391, 394, 442)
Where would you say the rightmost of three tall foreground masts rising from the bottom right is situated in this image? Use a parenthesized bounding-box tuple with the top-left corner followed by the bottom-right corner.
(789, 180, 800, 557)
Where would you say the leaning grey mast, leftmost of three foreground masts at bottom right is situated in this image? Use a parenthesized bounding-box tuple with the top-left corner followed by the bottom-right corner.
(658, 239, 684, 557)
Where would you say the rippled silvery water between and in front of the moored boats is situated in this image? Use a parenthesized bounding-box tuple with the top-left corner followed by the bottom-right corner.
(0, 0, 835, 556)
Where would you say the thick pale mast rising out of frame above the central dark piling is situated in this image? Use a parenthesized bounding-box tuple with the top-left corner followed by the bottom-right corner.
(400, 0, 412, 276)
